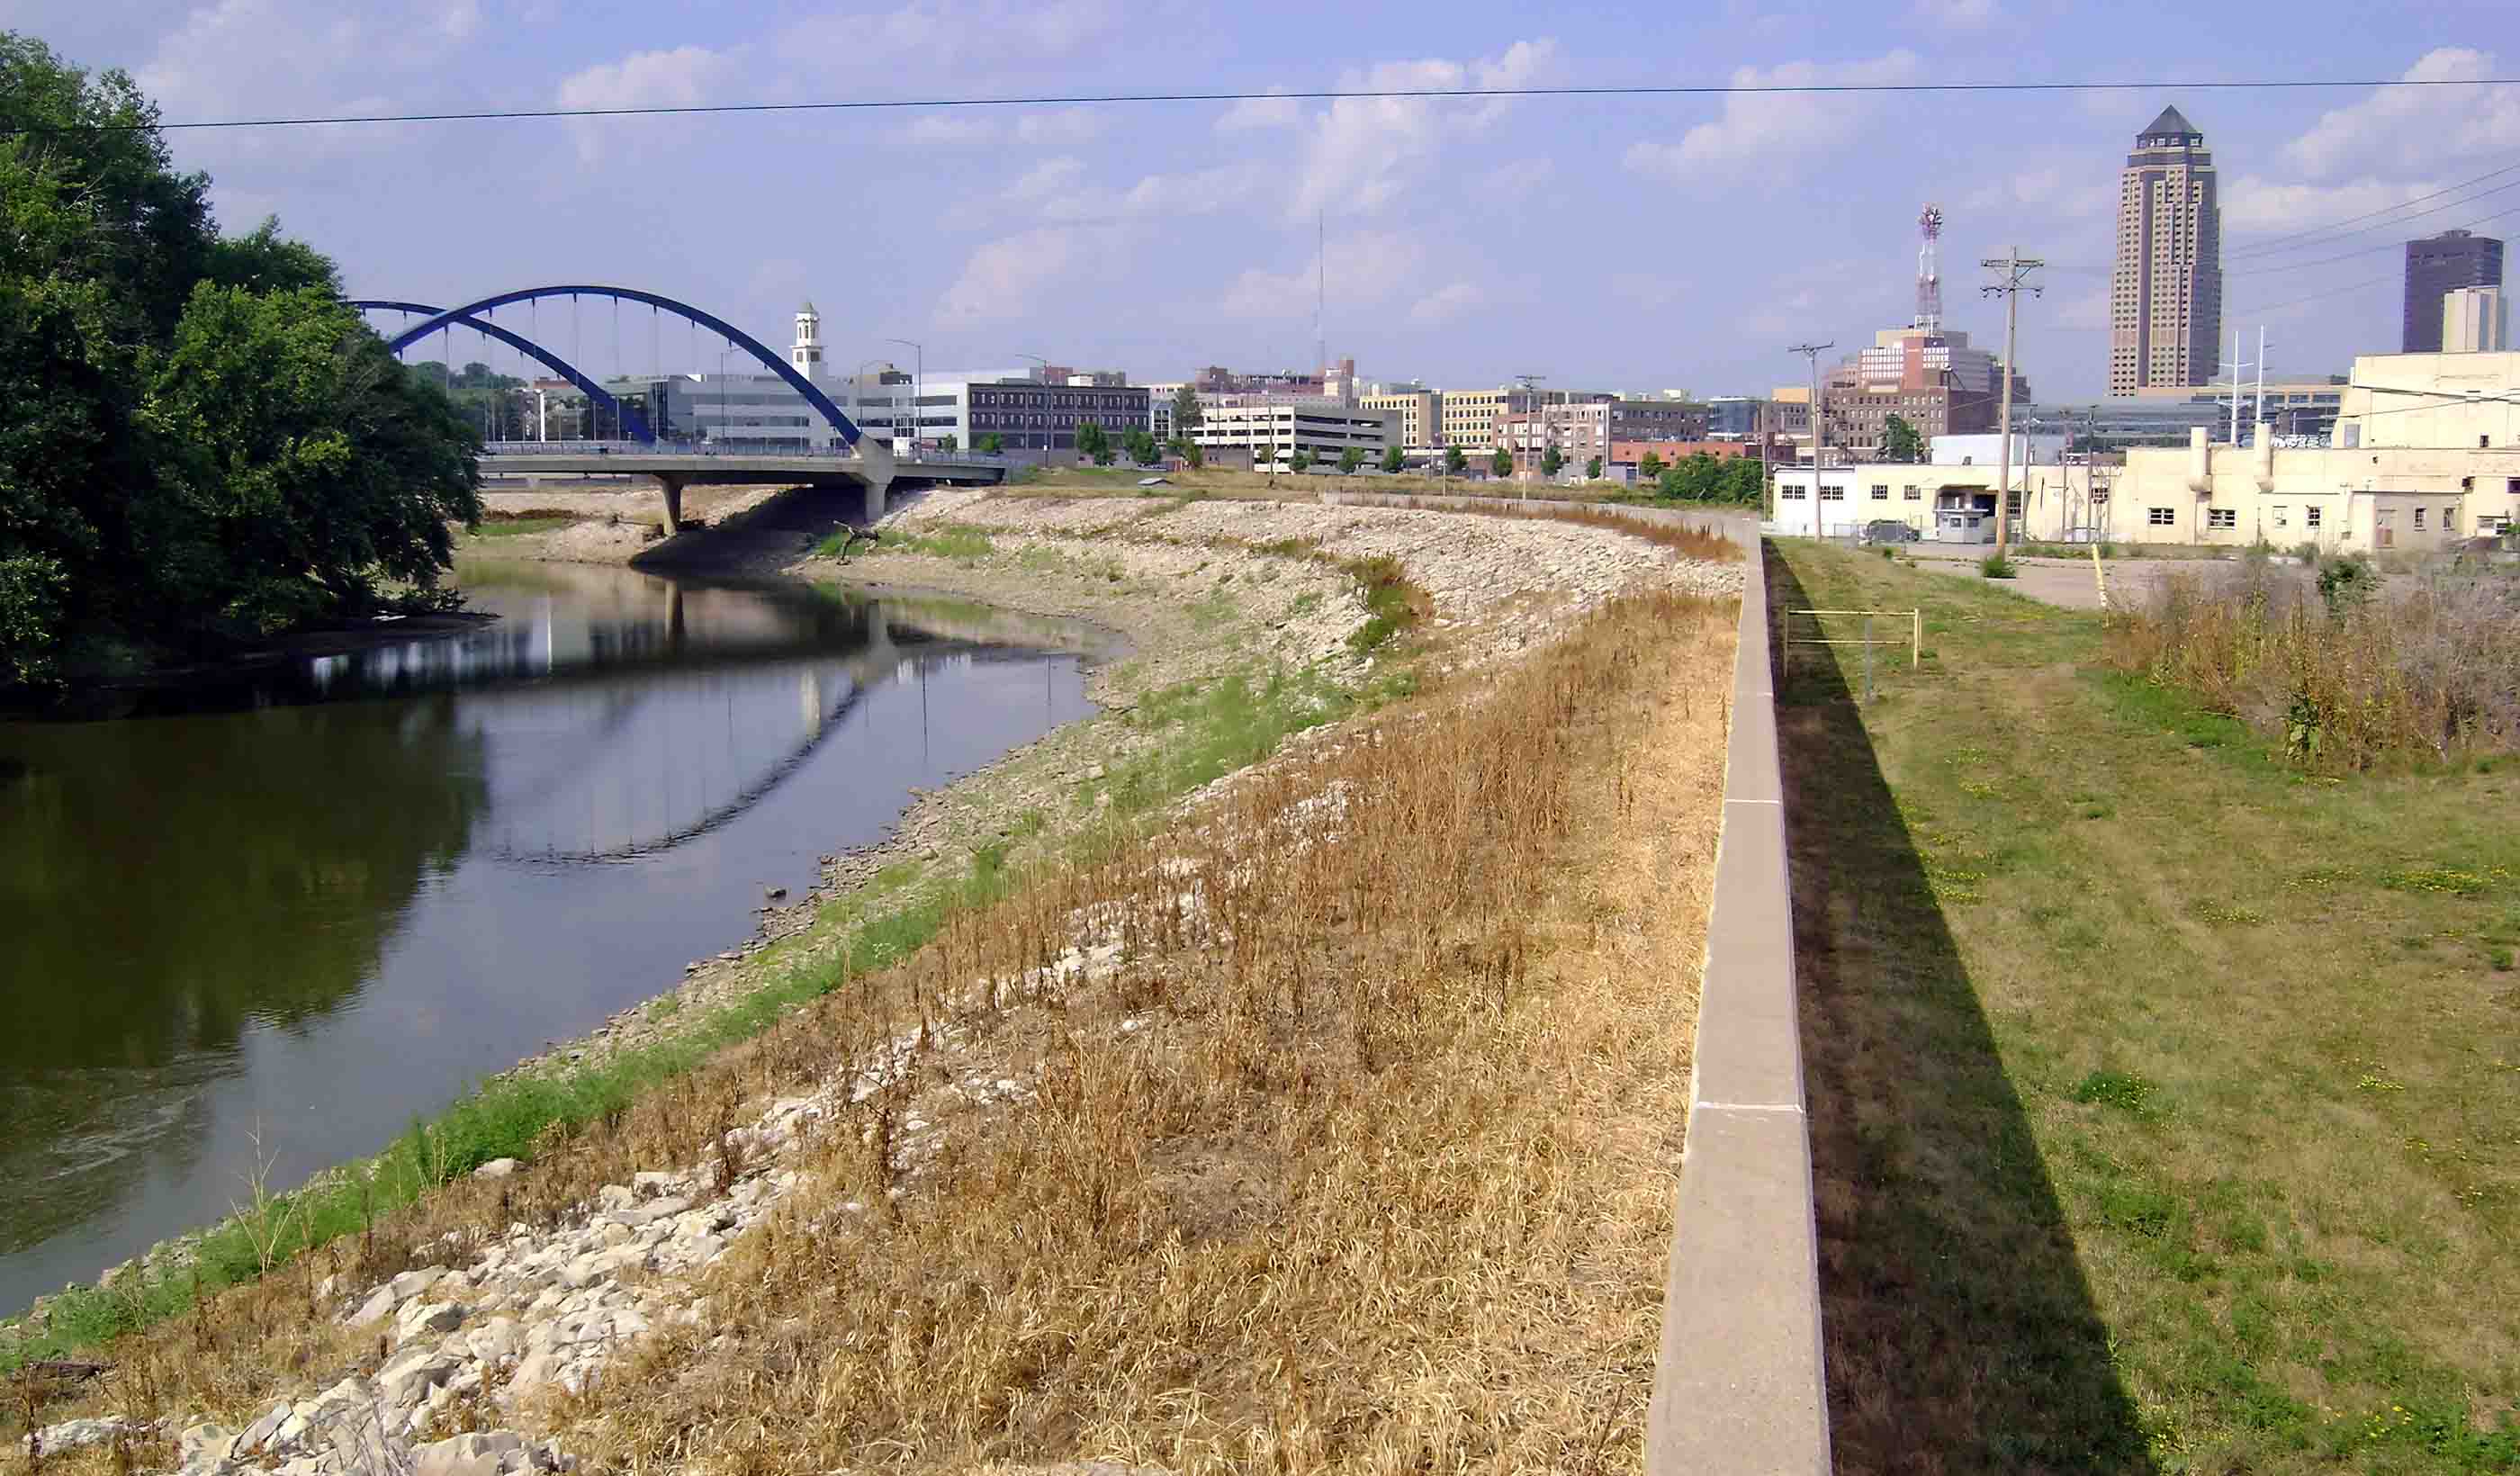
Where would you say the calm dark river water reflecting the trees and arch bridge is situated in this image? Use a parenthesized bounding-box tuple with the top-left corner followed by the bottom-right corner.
(0, 564, 1091, 1315)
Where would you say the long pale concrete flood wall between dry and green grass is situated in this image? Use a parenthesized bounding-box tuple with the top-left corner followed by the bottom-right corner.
(1320, 491, 1830, 1476)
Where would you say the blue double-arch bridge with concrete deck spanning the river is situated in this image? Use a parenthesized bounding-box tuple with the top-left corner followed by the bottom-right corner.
(350, 282, 1008, 534)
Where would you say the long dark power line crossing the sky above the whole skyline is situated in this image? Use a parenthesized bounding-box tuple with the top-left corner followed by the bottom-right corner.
(0, 78, 2520, 139)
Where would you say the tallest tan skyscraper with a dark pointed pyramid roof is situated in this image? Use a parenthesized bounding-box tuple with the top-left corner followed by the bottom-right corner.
(2110, 108, 2223, 395)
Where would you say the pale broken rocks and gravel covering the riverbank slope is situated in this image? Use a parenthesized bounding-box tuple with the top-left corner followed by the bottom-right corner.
(31, 491, 1739, 1476)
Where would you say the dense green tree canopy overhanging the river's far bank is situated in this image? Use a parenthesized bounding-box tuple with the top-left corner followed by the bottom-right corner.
(0, 32, 479, 685)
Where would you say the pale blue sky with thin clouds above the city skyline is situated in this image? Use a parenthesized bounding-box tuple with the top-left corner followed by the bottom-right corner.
(14, 0, 2520, 398)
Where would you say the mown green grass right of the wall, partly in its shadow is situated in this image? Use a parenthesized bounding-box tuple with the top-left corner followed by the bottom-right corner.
(1771, 544, 2520, 1471)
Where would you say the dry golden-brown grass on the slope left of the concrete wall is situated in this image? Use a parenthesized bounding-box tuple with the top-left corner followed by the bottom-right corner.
(13, 579, 1732, 1471)
